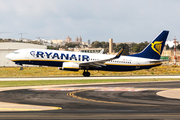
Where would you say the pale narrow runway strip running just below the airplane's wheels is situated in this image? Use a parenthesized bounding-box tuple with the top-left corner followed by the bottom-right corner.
(0, 75, 180, 81)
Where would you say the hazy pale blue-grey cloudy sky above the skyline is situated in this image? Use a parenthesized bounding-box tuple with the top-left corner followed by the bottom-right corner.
(0, 0, 180, 43)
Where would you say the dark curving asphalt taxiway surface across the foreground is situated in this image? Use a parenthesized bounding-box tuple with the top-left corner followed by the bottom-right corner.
(0, 81, 180, 120)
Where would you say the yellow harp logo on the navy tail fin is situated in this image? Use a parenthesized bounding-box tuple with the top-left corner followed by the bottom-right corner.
(151, 41, 163, 55)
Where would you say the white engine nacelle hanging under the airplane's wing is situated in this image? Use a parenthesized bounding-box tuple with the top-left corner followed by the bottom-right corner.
(62, 62, 79, 71)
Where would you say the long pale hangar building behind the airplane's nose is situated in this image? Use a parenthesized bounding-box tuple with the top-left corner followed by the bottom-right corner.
(0, 42, 46, 67)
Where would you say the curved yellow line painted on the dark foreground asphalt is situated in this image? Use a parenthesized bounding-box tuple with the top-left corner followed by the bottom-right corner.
(67, 89, 160, 106)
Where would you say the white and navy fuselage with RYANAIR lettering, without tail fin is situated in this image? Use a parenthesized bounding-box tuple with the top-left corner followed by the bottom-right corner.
(6, 49, 161, 71)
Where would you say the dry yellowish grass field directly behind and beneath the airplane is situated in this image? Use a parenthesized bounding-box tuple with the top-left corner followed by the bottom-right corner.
(0, 65, 180, 78)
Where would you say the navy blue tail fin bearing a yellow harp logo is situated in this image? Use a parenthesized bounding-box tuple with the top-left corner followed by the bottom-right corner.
(129, 30, 169, 59)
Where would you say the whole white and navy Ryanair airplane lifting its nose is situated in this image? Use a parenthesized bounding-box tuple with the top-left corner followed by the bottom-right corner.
(6, 30, 169, 77)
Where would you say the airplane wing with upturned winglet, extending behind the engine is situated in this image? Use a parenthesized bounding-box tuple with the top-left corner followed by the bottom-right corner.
(79, 48, 124, 67)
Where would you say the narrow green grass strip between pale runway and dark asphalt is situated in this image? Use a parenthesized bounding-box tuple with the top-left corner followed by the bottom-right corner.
(0, 78, 180, 87)
